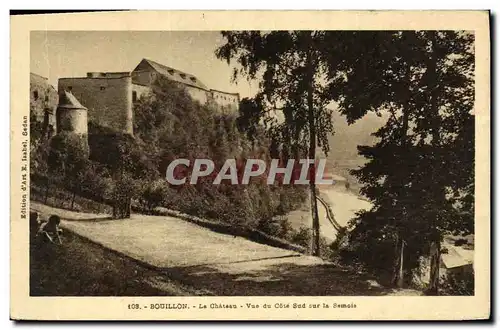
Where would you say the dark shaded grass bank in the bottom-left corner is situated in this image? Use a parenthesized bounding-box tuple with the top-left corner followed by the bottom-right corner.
(30, 231, 207, 296)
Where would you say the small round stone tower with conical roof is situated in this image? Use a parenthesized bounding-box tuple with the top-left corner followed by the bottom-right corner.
(56, 91, 88, 135)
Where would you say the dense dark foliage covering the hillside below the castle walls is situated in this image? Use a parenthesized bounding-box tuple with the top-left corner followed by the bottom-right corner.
(30, 65, 306, 235)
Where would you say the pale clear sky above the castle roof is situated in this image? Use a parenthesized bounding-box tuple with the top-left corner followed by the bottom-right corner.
(30, 31, 257, 97)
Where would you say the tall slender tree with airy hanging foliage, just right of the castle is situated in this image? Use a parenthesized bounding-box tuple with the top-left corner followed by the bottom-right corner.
(216, 31, 352, 255)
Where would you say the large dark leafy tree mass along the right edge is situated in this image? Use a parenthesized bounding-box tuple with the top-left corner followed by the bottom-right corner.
(337, 31, 474, 294)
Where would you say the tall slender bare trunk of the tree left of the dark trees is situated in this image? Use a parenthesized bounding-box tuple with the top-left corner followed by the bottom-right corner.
(307, 40, 321, 257)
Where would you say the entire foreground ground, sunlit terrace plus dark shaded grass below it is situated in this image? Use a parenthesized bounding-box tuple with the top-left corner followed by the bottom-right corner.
(32, 201, 418, 296)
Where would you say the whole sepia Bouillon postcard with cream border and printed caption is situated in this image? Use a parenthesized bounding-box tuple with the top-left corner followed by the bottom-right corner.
(10, 11, 491, 321)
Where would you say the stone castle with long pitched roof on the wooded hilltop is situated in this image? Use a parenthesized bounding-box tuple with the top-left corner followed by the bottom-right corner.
(54, 59, 240, 135)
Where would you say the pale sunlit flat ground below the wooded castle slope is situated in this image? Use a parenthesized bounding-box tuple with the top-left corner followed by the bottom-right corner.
(62, 214, 297, 269)
